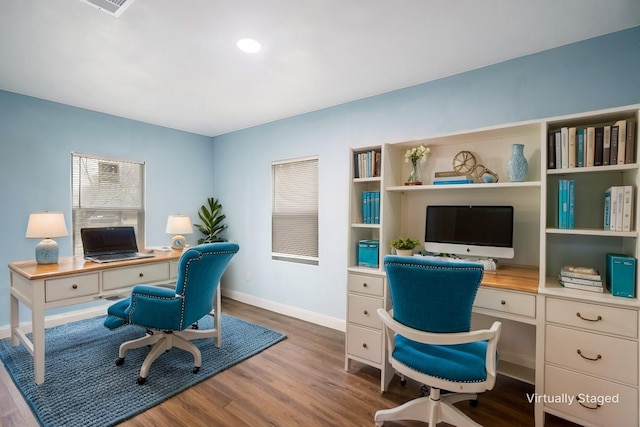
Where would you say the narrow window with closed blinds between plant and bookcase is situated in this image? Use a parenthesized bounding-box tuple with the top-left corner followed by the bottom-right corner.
(271, 157, 318, 265)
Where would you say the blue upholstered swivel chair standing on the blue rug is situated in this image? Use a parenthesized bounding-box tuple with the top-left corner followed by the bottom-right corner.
(104, 242, 239, 384)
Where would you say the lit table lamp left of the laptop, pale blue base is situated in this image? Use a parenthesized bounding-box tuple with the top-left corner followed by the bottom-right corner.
(26, 212, 68, 264)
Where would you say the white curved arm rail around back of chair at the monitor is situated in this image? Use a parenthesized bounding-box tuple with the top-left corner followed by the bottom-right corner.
(378, 308, 500, 345)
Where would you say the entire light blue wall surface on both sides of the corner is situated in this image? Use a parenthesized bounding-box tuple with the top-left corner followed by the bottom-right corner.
(0, 27, 640, 325)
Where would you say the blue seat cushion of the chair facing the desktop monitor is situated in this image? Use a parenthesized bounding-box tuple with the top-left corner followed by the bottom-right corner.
(393, 335, 488, 383)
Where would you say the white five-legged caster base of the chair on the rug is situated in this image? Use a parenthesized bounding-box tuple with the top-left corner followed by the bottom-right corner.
(116, 314, 220, 385)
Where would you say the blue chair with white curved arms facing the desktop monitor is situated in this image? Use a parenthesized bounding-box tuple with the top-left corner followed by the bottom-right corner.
(375, 255, 502, 427)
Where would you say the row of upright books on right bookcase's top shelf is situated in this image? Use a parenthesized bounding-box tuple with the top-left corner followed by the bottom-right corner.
(547, 119, 637, 169)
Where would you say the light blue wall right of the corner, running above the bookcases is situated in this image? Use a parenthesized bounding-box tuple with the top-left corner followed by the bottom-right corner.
(213, 27, 640, 320)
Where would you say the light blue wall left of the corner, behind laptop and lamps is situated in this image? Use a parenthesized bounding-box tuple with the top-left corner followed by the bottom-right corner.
(0, 91, 213, 325)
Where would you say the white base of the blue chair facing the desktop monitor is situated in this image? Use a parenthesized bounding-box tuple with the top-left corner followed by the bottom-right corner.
(375, 387, 482, 427)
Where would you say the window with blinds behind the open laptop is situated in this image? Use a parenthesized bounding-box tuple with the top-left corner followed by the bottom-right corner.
(71, 153, 144, 255)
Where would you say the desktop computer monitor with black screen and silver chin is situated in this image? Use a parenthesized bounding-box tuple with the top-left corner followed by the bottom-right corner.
(424, 205, 514, 258)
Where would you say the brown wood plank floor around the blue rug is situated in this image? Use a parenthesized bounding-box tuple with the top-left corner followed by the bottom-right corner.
(0, 299, 574, 427)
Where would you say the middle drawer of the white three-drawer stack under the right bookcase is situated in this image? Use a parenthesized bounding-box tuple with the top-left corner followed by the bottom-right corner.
(545, 325, 638, 385)
